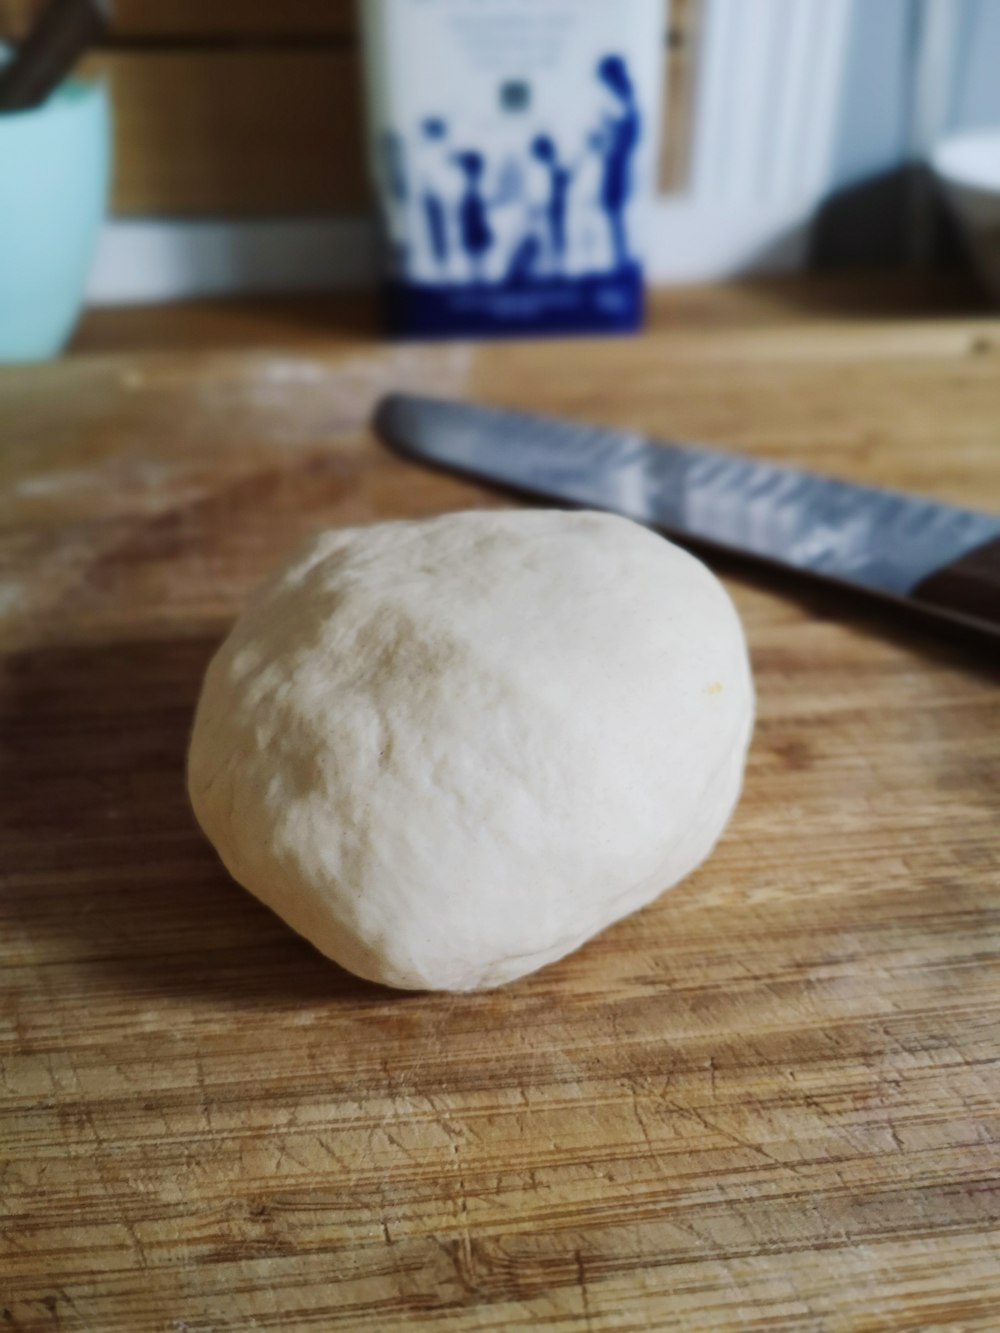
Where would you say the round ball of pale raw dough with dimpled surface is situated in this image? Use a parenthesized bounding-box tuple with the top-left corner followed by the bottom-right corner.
(188, 511, 753, 990)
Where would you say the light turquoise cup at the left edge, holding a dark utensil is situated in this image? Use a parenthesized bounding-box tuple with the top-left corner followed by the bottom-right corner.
(0, 79, 111, 361)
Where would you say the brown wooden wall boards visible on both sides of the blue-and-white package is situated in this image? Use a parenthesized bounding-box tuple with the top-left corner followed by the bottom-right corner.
(0, 0, 700, 217)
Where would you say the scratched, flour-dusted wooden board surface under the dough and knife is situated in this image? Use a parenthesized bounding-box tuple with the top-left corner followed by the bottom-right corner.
(0, 278, 1000, 1333)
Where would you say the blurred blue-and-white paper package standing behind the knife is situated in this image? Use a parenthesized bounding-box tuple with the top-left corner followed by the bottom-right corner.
(360, 0, 665, 337)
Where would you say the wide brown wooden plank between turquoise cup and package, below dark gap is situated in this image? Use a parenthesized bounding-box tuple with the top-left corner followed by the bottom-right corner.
(84, 51, 367, 217)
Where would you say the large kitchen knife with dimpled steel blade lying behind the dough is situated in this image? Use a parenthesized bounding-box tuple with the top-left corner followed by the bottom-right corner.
(373, 395, 1000, 637)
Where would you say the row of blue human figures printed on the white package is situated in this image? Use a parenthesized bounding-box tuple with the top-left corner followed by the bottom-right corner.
(380, 53, 641, 311)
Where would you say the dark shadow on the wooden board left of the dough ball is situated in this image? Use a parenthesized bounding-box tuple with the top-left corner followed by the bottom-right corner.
(0, 639, 404, 1006)
